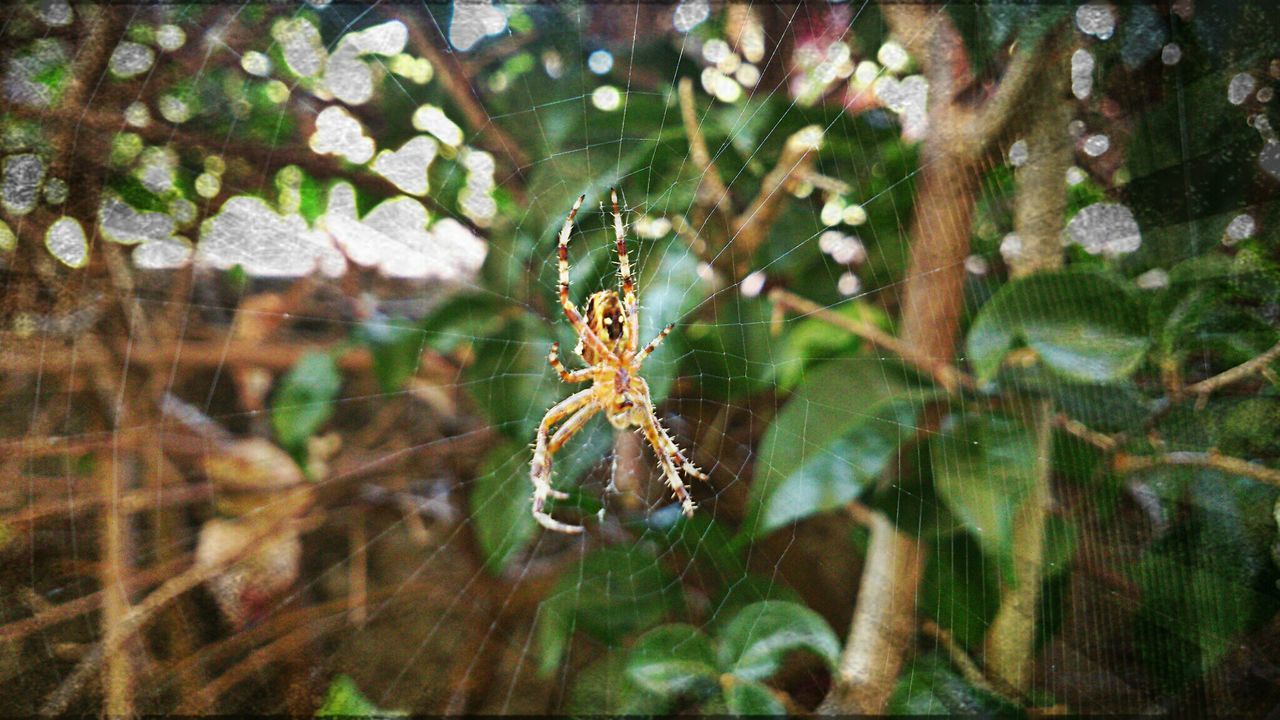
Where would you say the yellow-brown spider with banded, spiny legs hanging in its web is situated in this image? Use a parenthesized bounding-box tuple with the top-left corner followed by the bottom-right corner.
(530, 190, 707, 533)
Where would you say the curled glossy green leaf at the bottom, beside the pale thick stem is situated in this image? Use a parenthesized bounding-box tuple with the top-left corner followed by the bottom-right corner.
(718, 600, 840, 680)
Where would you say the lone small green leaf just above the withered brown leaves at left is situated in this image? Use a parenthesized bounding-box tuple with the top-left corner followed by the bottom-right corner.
(271, 351, 342, 459)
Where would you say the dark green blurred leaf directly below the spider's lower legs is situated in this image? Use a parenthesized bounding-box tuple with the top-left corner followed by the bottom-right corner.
(538, 546, 684, 673)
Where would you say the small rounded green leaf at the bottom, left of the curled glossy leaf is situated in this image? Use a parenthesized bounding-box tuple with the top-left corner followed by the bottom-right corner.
(626, 624, 719, 698)
